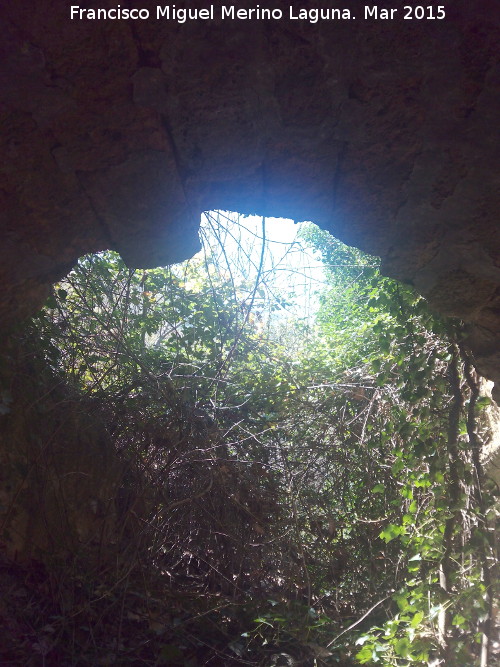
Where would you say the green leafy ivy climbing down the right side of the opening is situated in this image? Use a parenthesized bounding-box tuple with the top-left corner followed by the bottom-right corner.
(298, 229, 495, 665)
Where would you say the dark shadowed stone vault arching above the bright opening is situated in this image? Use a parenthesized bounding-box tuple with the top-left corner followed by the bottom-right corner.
(0, 0, 500, 394)
